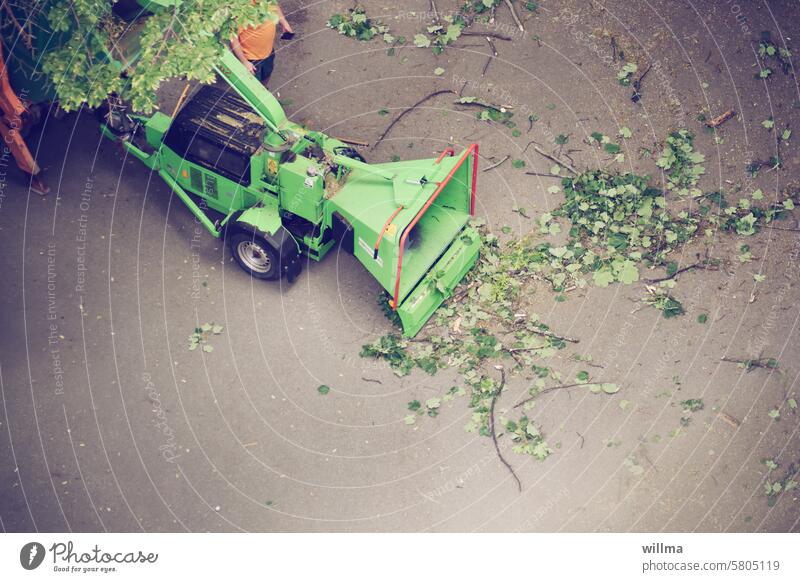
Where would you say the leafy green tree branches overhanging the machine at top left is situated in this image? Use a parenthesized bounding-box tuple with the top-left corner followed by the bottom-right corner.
(36, 0, 274, 112)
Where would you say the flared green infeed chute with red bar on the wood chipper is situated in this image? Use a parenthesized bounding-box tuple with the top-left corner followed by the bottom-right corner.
(329, 144, 480, 336)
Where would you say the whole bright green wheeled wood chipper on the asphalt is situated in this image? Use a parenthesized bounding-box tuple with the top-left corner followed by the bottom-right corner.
(103, 51, 480, 336)
